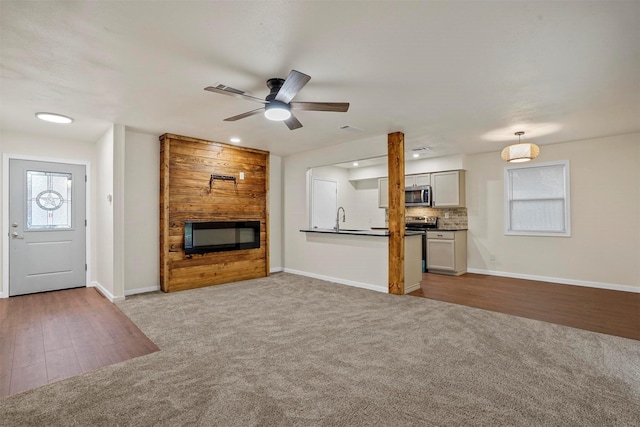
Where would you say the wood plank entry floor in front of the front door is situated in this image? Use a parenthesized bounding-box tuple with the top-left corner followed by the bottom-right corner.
(0, 288, 158, 397)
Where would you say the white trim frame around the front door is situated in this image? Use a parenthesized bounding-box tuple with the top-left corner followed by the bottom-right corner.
(0, 154, 92, 298)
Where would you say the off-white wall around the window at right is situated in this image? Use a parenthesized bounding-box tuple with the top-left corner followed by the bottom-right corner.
(467, 134, 640, 290)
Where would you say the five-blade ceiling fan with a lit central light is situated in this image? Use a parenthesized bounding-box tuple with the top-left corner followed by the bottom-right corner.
(204, 70, 349, 130)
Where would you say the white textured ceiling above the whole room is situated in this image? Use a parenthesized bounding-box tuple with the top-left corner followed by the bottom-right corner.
(0, 0, 640, 156)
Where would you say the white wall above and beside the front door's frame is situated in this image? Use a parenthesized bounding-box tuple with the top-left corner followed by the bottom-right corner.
(0, 130, 96, 296)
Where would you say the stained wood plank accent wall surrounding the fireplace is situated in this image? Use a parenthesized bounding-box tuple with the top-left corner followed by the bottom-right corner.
(160, 134, 269, 292)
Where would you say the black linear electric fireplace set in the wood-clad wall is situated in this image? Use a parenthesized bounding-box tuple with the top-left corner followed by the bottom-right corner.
(184, 221, 260, 255)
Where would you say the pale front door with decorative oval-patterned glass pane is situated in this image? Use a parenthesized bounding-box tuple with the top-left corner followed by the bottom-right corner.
(8, 159, 86, 296)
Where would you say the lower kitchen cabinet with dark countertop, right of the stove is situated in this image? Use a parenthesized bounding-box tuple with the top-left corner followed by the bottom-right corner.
(427, 230, 467, 276)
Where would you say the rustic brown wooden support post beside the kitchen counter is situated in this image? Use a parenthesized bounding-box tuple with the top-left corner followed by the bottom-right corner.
(387, 132, 405, 295)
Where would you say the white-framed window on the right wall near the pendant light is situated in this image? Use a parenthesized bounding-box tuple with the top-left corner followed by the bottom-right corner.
(504, 161, 571, 237)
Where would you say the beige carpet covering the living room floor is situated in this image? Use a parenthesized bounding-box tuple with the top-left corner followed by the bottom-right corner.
(0, 273, 640, 426)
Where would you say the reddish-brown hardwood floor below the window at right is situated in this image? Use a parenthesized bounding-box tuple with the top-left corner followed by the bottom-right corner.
(409, 273, 640, 340)
